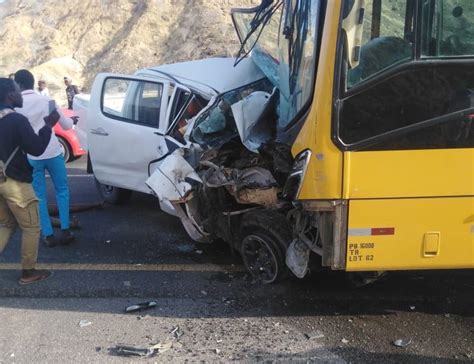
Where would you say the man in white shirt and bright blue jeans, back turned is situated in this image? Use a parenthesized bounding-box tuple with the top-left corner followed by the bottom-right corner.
(15, 70, 74, 247)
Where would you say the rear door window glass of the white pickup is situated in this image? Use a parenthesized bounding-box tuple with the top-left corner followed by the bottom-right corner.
(102, 78, 163, 128)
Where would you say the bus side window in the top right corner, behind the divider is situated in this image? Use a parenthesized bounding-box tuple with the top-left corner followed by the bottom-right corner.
(422, 0, 474, 57)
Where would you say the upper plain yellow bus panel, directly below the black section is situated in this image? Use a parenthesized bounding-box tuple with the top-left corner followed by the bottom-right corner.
(344, 149, 474, 199)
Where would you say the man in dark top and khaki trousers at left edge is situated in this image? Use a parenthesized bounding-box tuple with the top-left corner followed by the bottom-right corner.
(0, 78, 59, 285)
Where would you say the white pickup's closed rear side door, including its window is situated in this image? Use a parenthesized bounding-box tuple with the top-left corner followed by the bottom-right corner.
(88, 74, 171, 193)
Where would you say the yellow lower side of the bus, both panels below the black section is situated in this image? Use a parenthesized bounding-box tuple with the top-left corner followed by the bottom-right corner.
(344, 149, 474, 271)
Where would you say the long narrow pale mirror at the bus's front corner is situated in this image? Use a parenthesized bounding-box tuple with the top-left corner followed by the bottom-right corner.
(342, 0, 365, 69)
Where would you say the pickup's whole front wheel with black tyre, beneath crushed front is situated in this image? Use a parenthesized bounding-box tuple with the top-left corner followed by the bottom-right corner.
(240, 210, 291, 284)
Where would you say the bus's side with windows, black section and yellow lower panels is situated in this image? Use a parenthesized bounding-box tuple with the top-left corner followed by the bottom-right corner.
(334, 0, 474, 271)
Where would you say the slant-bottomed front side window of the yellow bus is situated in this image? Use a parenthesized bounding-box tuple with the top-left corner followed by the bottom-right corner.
(347, 0, 414, 88)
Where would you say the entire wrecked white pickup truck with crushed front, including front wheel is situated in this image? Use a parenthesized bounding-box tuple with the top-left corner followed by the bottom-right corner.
(74, 58, 293, 283)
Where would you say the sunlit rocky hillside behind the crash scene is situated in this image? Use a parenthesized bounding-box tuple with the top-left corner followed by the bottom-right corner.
(0, 0, 259, 102)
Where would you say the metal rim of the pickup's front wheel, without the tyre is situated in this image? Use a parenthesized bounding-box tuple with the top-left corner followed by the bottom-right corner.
(242, 235, 279, 283)
